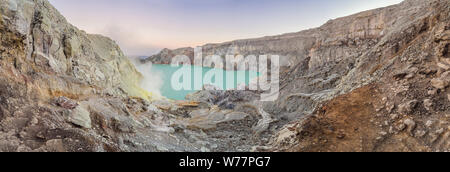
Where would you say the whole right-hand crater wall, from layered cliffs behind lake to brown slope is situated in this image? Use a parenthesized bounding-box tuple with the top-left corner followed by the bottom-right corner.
(145, 0, 450, 151)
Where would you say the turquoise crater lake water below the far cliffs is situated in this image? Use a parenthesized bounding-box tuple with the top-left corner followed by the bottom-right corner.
(152, 64, 259, 100)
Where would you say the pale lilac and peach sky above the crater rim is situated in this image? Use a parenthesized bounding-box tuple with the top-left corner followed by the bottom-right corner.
(50, 0, 402, 55)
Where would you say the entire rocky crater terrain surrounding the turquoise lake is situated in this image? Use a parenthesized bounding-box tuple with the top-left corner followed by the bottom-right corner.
(0, 0, 450, 152)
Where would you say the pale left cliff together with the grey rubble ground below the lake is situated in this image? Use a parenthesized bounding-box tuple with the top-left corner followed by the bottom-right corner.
(0, 0, 284, 152)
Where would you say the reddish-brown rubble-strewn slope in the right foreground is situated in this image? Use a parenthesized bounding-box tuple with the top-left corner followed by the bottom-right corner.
(272, 0, 450, 151)
